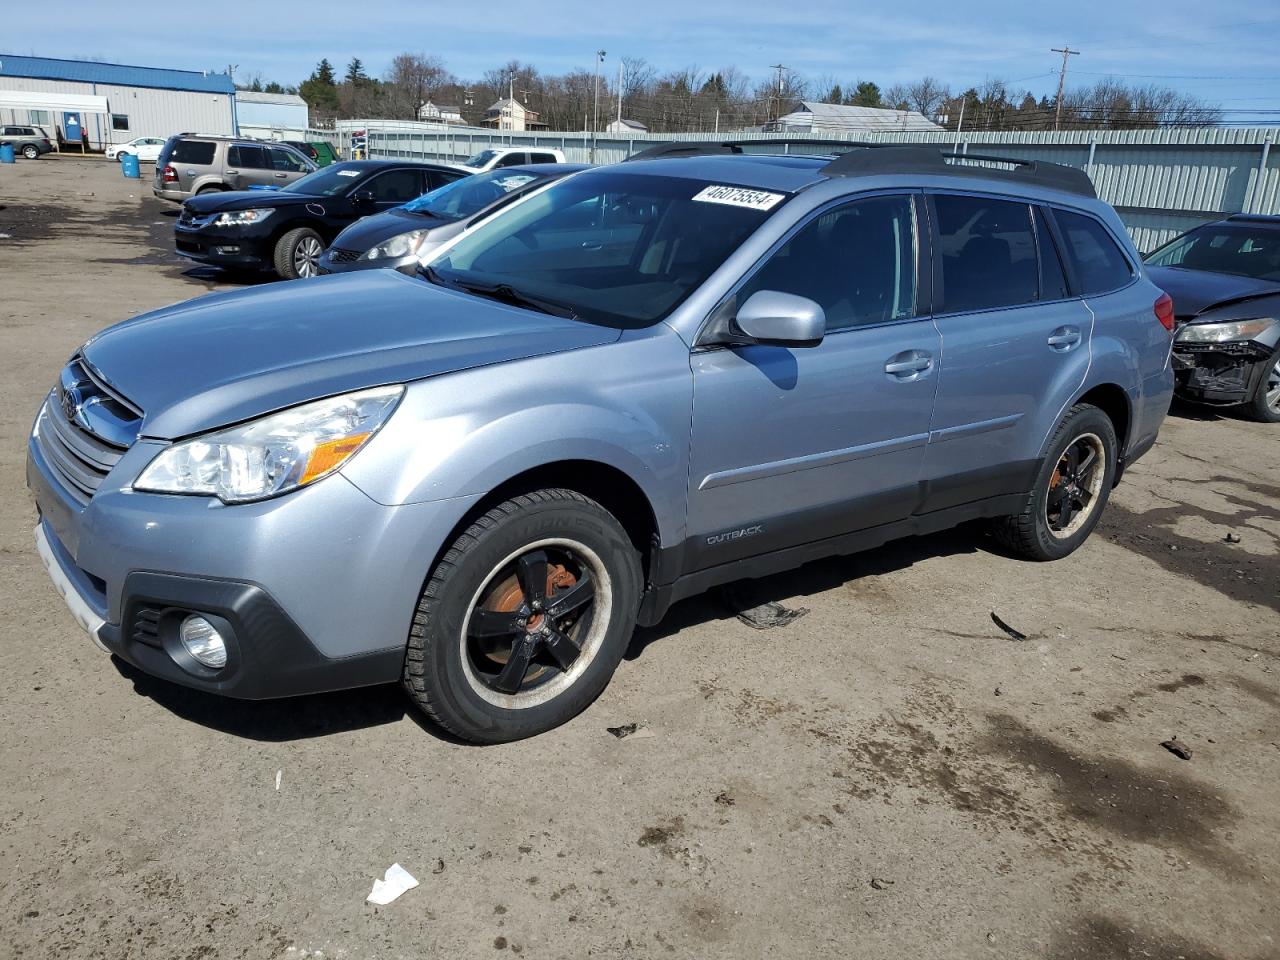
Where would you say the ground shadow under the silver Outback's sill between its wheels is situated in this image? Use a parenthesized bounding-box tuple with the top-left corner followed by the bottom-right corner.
(625, 521, 983, 660)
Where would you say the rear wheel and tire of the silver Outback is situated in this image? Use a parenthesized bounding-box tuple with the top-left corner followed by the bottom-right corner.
(993, 403, 1119, 561)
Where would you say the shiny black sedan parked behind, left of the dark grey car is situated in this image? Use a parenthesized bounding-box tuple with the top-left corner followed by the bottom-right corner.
(174, 160, 467, 280)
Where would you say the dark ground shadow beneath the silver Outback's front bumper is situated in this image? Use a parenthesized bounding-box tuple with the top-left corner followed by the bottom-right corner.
(111, 657, 462, 745)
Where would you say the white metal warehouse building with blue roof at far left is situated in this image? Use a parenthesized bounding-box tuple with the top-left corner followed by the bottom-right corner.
(0, 54, 237, 148)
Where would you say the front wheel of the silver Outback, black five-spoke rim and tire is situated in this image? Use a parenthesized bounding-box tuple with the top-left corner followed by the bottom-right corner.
(403, 489, 641, 744)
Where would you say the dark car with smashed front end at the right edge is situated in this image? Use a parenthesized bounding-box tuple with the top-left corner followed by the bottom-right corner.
(1147, 215, 1280, 424)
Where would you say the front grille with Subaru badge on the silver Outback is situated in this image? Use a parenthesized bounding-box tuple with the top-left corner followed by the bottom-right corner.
(36, 357, 142, 503)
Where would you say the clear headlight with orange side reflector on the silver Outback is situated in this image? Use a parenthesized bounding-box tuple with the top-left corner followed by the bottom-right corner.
(133, 385, 404, 503)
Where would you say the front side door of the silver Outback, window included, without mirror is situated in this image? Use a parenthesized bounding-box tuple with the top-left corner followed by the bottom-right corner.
(685, 195, 941, 571)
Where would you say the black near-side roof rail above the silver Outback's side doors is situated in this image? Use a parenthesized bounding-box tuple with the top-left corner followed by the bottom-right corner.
(822, 145, 1097, 197)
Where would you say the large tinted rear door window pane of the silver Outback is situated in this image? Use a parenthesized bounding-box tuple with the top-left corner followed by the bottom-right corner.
(933, 193, 1039, 314)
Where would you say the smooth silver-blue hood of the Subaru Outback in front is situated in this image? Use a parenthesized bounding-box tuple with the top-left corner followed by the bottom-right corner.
(83, 270, 621, 439)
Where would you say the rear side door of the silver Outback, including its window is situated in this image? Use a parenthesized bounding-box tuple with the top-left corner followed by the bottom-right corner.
(922, 191, 1093, 512)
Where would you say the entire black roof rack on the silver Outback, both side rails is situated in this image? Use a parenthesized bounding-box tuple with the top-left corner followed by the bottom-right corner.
(627, 137, 1097, 197)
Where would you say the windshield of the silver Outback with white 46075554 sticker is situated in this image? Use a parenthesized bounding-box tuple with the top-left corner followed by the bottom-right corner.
(424, 172, 786, 328)
